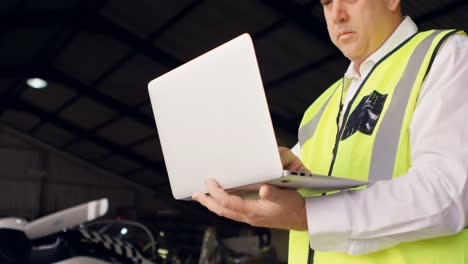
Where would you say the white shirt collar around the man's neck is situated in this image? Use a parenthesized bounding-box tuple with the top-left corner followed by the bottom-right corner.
(345, 17, 418, 79)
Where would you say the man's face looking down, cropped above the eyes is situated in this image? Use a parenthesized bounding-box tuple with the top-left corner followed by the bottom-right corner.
(320, 0, 399, 64)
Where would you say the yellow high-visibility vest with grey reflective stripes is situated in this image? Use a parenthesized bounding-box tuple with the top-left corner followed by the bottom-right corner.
(289, 30, 468, 264)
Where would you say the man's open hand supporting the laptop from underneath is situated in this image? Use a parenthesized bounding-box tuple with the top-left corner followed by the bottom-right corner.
(192, 179, 307, 230)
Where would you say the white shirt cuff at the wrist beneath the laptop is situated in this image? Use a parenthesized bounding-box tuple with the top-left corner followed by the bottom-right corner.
(305, 191, 351, 252)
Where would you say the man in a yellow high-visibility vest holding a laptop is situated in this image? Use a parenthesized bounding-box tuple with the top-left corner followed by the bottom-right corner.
(193, 0, 468, 263)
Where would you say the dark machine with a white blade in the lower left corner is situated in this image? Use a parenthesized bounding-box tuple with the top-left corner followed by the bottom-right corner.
(0, 199, 154, 264)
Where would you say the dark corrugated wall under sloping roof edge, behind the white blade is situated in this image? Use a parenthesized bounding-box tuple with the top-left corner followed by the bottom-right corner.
(0, 125, 155, 219)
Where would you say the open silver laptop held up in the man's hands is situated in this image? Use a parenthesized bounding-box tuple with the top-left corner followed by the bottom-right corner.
(148, 34, 366, 199)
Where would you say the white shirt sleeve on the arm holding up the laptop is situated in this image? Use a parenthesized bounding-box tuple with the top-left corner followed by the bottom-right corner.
(306, 35, 468, 255)
